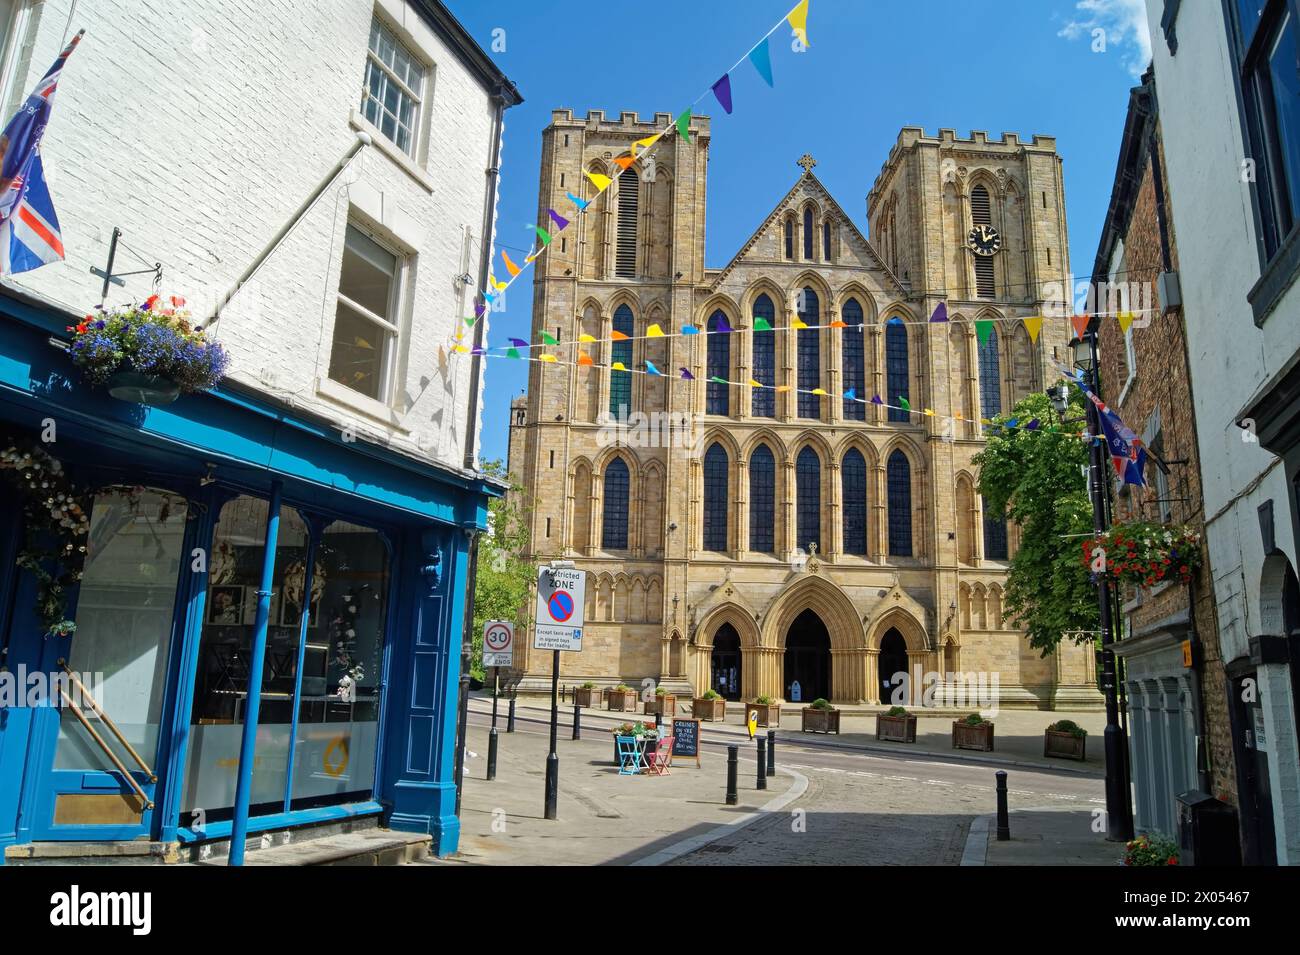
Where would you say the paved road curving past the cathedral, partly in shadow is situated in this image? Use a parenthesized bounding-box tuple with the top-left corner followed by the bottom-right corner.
(469, 712, 1105, 865)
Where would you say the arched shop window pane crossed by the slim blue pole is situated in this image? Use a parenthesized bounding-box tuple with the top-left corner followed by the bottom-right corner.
(181, 496, 307, 825)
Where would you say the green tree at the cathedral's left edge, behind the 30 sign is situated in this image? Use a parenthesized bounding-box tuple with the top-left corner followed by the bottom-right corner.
(469, 460, 536, 680)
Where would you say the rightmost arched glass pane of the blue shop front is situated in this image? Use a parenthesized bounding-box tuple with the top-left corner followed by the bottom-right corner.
(293, 521, 389, 809)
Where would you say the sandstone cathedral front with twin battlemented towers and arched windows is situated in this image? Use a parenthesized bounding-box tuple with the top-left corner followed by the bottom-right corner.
(510, 110, 1100, 707)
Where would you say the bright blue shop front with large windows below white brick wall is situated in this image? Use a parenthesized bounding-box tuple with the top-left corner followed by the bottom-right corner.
(0, 292, 488, 854)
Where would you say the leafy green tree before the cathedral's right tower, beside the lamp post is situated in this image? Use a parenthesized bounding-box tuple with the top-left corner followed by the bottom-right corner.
(974, 388, 1097, 656)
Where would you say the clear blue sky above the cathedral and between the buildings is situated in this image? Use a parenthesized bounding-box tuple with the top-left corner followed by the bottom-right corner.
(447, 0, 1148, 459)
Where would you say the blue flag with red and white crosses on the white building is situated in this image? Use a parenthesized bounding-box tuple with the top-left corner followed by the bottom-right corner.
(0, 30, 86, 275)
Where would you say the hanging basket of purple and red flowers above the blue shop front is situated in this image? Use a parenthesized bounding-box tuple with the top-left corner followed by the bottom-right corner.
(68, 295, 230, 405)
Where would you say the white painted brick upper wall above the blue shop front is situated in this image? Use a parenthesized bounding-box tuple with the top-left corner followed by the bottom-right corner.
(1, 0, 491, 466)
